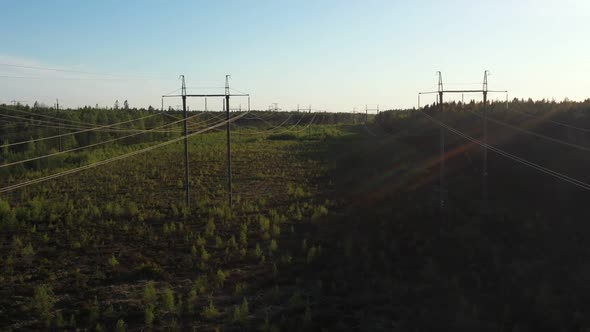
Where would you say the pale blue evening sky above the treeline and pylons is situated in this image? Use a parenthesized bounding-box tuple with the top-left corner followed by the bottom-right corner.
(0, 0, 590, 112)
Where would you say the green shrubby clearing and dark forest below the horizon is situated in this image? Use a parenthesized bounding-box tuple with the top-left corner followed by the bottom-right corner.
(0, 99, 590, 331)
